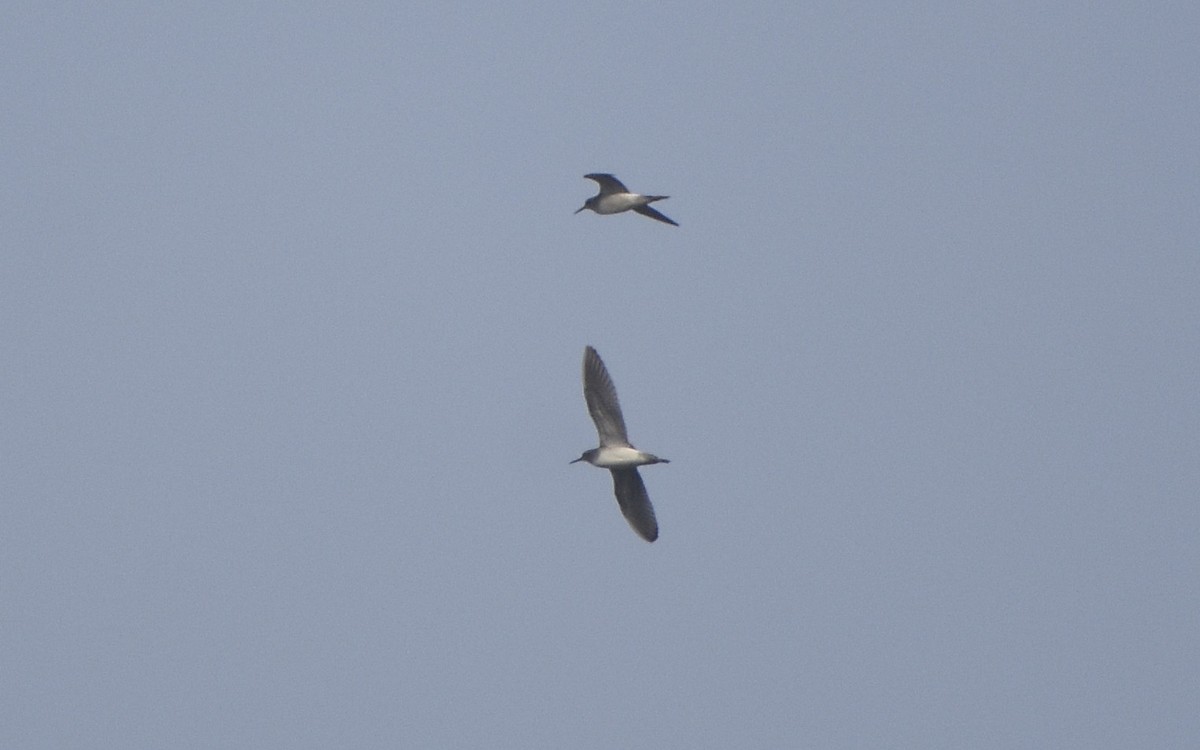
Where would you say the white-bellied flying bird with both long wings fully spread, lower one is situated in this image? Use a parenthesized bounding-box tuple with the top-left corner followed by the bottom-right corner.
(571, 347, 671, 541)
